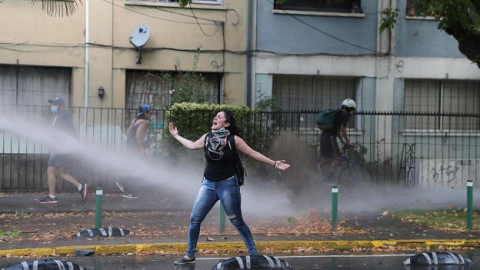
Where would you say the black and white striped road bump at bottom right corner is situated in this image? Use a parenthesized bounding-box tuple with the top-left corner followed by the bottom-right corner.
(403, 252, 472, 266)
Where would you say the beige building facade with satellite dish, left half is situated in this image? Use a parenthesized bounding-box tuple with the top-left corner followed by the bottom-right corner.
(0, 0, 248, 108)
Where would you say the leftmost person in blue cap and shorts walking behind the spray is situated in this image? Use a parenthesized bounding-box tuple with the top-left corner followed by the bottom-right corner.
(39, 97, 88, 203)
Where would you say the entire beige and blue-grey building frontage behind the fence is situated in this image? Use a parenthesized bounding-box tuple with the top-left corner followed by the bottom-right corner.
(0, 0, 480, 190)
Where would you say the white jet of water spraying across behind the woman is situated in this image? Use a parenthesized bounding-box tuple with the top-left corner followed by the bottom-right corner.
(0, 112, 479, 217)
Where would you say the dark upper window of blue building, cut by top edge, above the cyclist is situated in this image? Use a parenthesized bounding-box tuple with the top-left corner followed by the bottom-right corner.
(274, 0, 362, 13)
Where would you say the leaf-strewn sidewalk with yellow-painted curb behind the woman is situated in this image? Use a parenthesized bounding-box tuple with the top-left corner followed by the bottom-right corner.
(0, 193, 480, 257)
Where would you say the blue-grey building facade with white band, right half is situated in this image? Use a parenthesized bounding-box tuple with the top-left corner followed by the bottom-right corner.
(252, 0, 480, 184)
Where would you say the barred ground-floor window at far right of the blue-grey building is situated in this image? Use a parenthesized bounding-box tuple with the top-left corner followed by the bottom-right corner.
(404, 80, 480, 131)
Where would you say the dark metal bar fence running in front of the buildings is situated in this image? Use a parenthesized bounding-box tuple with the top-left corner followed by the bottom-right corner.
(0, 106, 480, 192)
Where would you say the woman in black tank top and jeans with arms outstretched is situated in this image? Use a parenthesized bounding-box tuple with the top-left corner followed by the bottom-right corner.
(168, 110, 290, 265)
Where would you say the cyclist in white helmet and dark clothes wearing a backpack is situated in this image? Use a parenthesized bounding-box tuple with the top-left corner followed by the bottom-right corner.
(317, 98, 357, 180)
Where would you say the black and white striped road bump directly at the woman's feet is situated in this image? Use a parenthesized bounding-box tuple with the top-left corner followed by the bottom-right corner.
(212, 255, 293, 270)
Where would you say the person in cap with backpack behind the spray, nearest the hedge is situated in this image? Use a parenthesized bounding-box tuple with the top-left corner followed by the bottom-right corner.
(116, 104, 152, 199)
